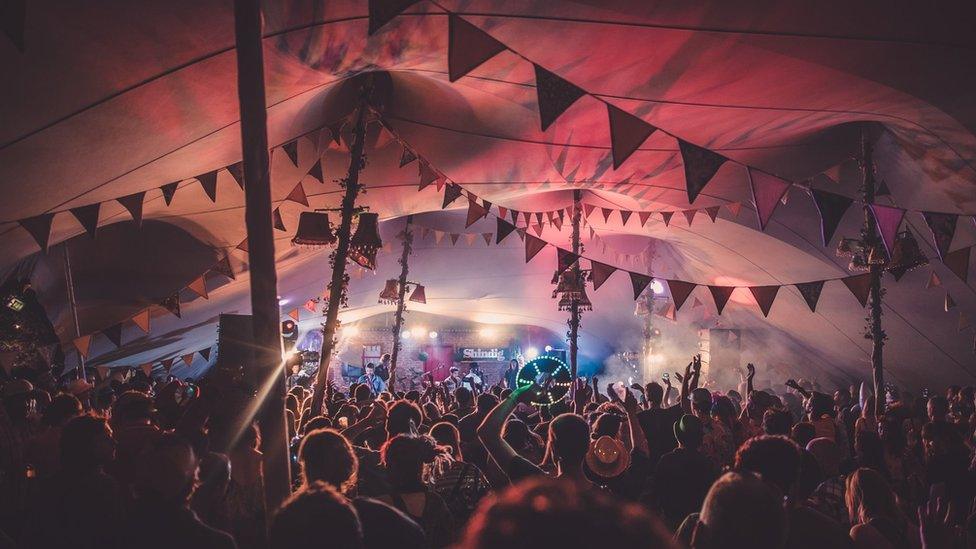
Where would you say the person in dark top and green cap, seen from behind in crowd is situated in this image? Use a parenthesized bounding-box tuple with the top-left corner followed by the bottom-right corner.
(653, 414, 717, 530)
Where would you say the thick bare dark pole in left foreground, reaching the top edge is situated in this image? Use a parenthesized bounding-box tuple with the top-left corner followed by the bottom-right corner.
(234, 0, 291, 510)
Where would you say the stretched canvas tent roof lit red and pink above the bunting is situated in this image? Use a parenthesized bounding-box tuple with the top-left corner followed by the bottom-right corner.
(0, 0, 976, 385)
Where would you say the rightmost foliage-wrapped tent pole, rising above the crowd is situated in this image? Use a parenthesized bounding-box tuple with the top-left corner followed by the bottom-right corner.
(861, 131, 885, 417)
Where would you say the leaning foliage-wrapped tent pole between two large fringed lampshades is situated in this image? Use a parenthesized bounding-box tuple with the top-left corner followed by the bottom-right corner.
(312, 79, 372, 417)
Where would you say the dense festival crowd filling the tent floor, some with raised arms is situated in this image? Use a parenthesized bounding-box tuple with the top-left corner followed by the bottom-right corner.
(0, 357, 976, 549)
